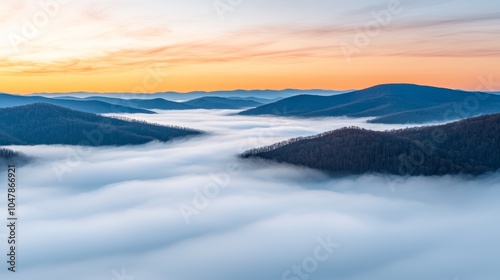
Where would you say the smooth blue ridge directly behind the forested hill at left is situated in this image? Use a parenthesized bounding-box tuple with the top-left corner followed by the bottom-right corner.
(0, 94, 155, 114)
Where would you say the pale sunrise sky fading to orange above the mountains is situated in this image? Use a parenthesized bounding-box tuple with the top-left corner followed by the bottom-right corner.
(0, 0, 500, 93)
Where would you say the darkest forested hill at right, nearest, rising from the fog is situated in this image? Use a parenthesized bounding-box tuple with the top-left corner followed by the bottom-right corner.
(242, 114, 500, 175)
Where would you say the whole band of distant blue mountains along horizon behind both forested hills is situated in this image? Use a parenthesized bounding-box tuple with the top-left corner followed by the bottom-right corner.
(0, 84, 500, 124)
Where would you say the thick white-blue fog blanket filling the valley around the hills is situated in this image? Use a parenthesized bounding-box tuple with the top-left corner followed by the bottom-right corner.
(0, 110, 500, 280)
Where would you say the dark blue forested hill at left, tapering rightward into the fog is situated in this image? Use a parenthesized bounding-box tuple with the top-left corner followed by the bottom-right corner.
(0, 103, 202, 146)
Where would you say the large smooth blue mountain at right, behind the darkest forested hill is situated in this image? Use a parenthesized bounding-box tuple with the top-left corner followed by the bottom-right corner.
(240, 84, 500, 124)
